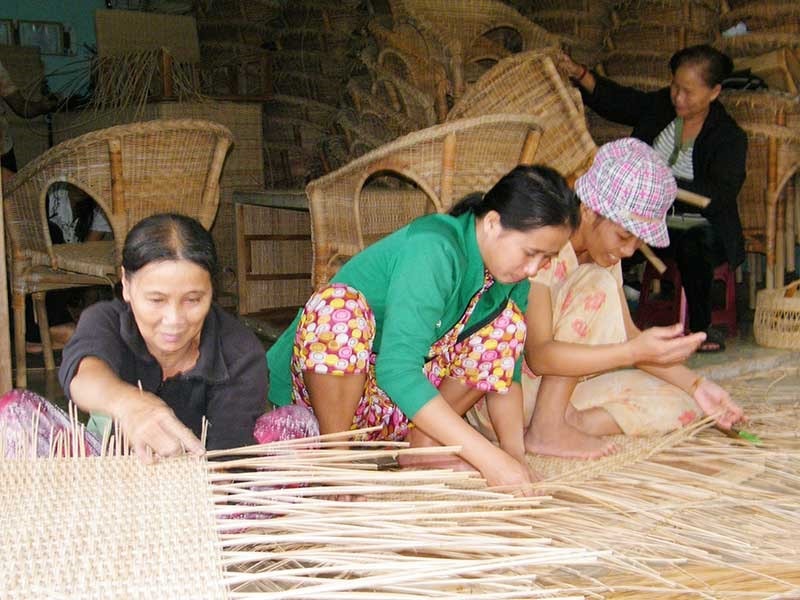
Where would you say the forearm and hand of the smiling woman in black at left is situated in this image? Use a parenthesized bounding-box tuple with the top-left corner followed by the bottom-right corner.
(69, 356, 205, 463)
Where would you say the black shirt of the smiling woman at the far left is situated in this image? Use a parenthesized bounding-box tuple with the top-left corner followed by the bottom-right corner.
(58, 300, 267, 450)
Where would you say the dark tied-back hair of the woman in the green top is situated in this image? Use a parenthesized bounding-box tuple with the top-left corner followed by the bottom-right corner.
(450, 165, 580, 231)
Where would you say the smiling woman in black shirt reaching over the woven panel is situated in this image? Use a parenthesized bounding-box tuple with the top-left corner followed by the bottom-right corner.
(59, 214, 267, 461)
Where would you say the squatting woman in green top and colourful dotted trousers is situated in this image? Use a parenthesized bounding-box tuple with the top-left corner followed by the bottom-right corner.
(267, 166, 578, 492)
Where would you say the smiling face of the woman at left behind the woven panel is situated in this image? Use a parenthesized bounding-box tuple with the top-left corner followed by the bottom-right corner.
(122, 260, 213, 359)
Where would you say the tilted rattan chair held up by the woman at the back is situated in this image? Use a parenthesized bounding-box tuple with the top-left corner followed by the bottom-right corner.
(447, 50, 597, 176)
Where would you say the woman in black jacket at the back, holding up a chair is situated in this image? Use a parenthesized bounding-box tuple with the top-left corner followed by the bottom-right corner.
(559, 44, 747, 352)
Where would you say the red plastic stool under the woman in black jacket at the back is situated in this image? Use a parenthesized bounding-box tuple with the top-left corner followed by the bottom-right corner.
(634, 260, 738, 336)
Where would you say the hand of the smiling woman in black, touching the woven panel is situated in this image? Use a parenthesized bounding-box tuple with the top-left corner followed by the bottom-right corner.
(114, 390, 205, 464)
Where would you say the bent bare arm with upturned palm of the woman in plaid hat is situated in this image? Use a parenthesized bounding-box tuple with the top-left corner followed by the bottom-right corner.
(525, 282, 702, 377)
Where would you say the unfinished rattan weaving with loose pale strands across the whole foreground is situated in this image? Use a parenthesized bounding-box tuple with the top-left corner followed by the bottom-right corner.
(0, 368, 800, 600)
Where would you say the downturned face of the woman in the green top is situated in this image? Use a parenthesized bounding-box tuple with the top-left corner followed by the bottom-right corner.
(481, 212, 572, 283)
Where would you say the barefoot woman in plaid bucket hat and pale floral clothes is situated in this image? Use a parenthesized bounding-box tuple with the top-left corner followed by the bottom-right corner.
(468, 138, 742, 458)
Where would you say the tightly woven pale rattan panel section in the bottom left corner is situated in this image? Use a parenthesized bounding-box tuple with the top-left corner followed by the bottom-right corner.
(0, 457, 226, 600)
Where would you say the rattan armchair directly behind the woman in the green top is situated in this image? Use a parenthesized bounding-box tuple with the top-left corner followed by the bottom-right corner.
(306, 114, 542, 286)
